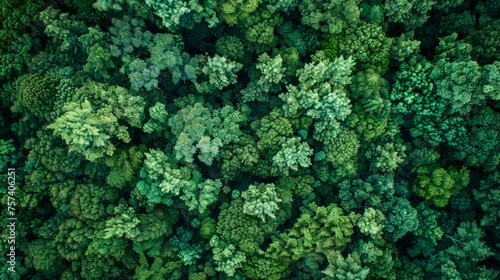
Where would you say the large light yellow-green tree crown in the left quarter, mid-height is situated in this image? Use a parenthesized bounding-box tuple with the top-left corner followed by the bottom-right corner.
(48, 82, 144, 161)
